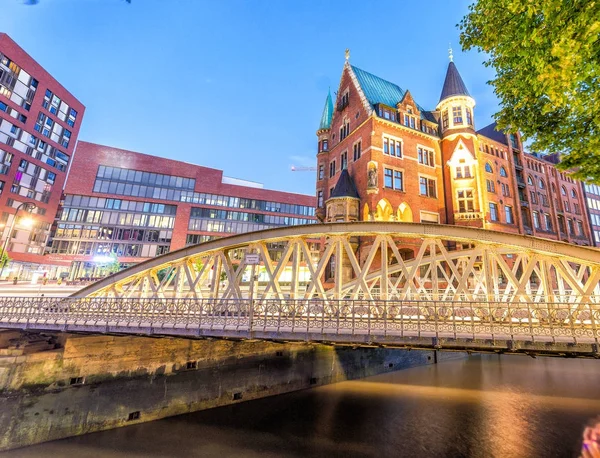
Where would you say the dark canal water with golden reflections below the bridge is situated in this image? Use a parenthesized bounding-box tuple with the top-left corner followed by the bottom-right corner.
(6, 355, 600, 458)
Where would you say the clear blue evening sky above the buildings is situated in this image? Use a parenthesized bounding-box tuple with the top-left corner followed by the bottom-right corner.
(0, 0, 497, 194)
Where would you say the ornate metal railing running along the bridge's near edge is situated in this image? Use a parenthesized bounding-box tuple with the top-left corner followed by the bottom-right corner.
(0, 297, 600, 343)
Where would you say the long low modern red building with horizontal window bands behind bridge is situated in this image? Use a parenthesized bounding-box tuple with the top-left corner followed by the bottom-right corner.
(46, 141, 316, 279)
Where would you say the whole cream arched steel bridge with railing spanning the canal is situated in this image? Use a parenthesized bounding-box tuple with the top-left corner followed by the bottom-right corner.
(0, 222, 600, 356)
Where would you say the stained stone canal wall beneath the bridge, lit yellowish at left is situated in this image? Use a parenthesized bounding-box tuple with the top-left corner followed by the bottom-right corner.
(0, 333, 462, 450)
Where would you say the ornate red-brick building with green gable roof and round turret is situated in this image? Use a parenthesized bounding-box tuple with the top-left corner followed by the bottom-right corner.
(316, 53, 592, 245)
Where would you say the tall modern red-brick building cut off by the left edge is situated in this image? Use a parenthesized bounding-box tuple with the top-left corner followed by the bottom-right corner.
(0, 33, 85, 278)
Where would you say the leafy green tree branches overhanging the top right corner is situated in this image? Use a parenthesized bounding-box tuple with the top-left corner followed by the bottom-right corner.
(458, 0, 600, 182)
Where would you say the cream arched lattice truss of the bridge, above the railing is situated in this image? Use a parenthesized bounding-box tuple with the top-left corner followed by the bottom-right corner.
(77, 222, 600, 304)
